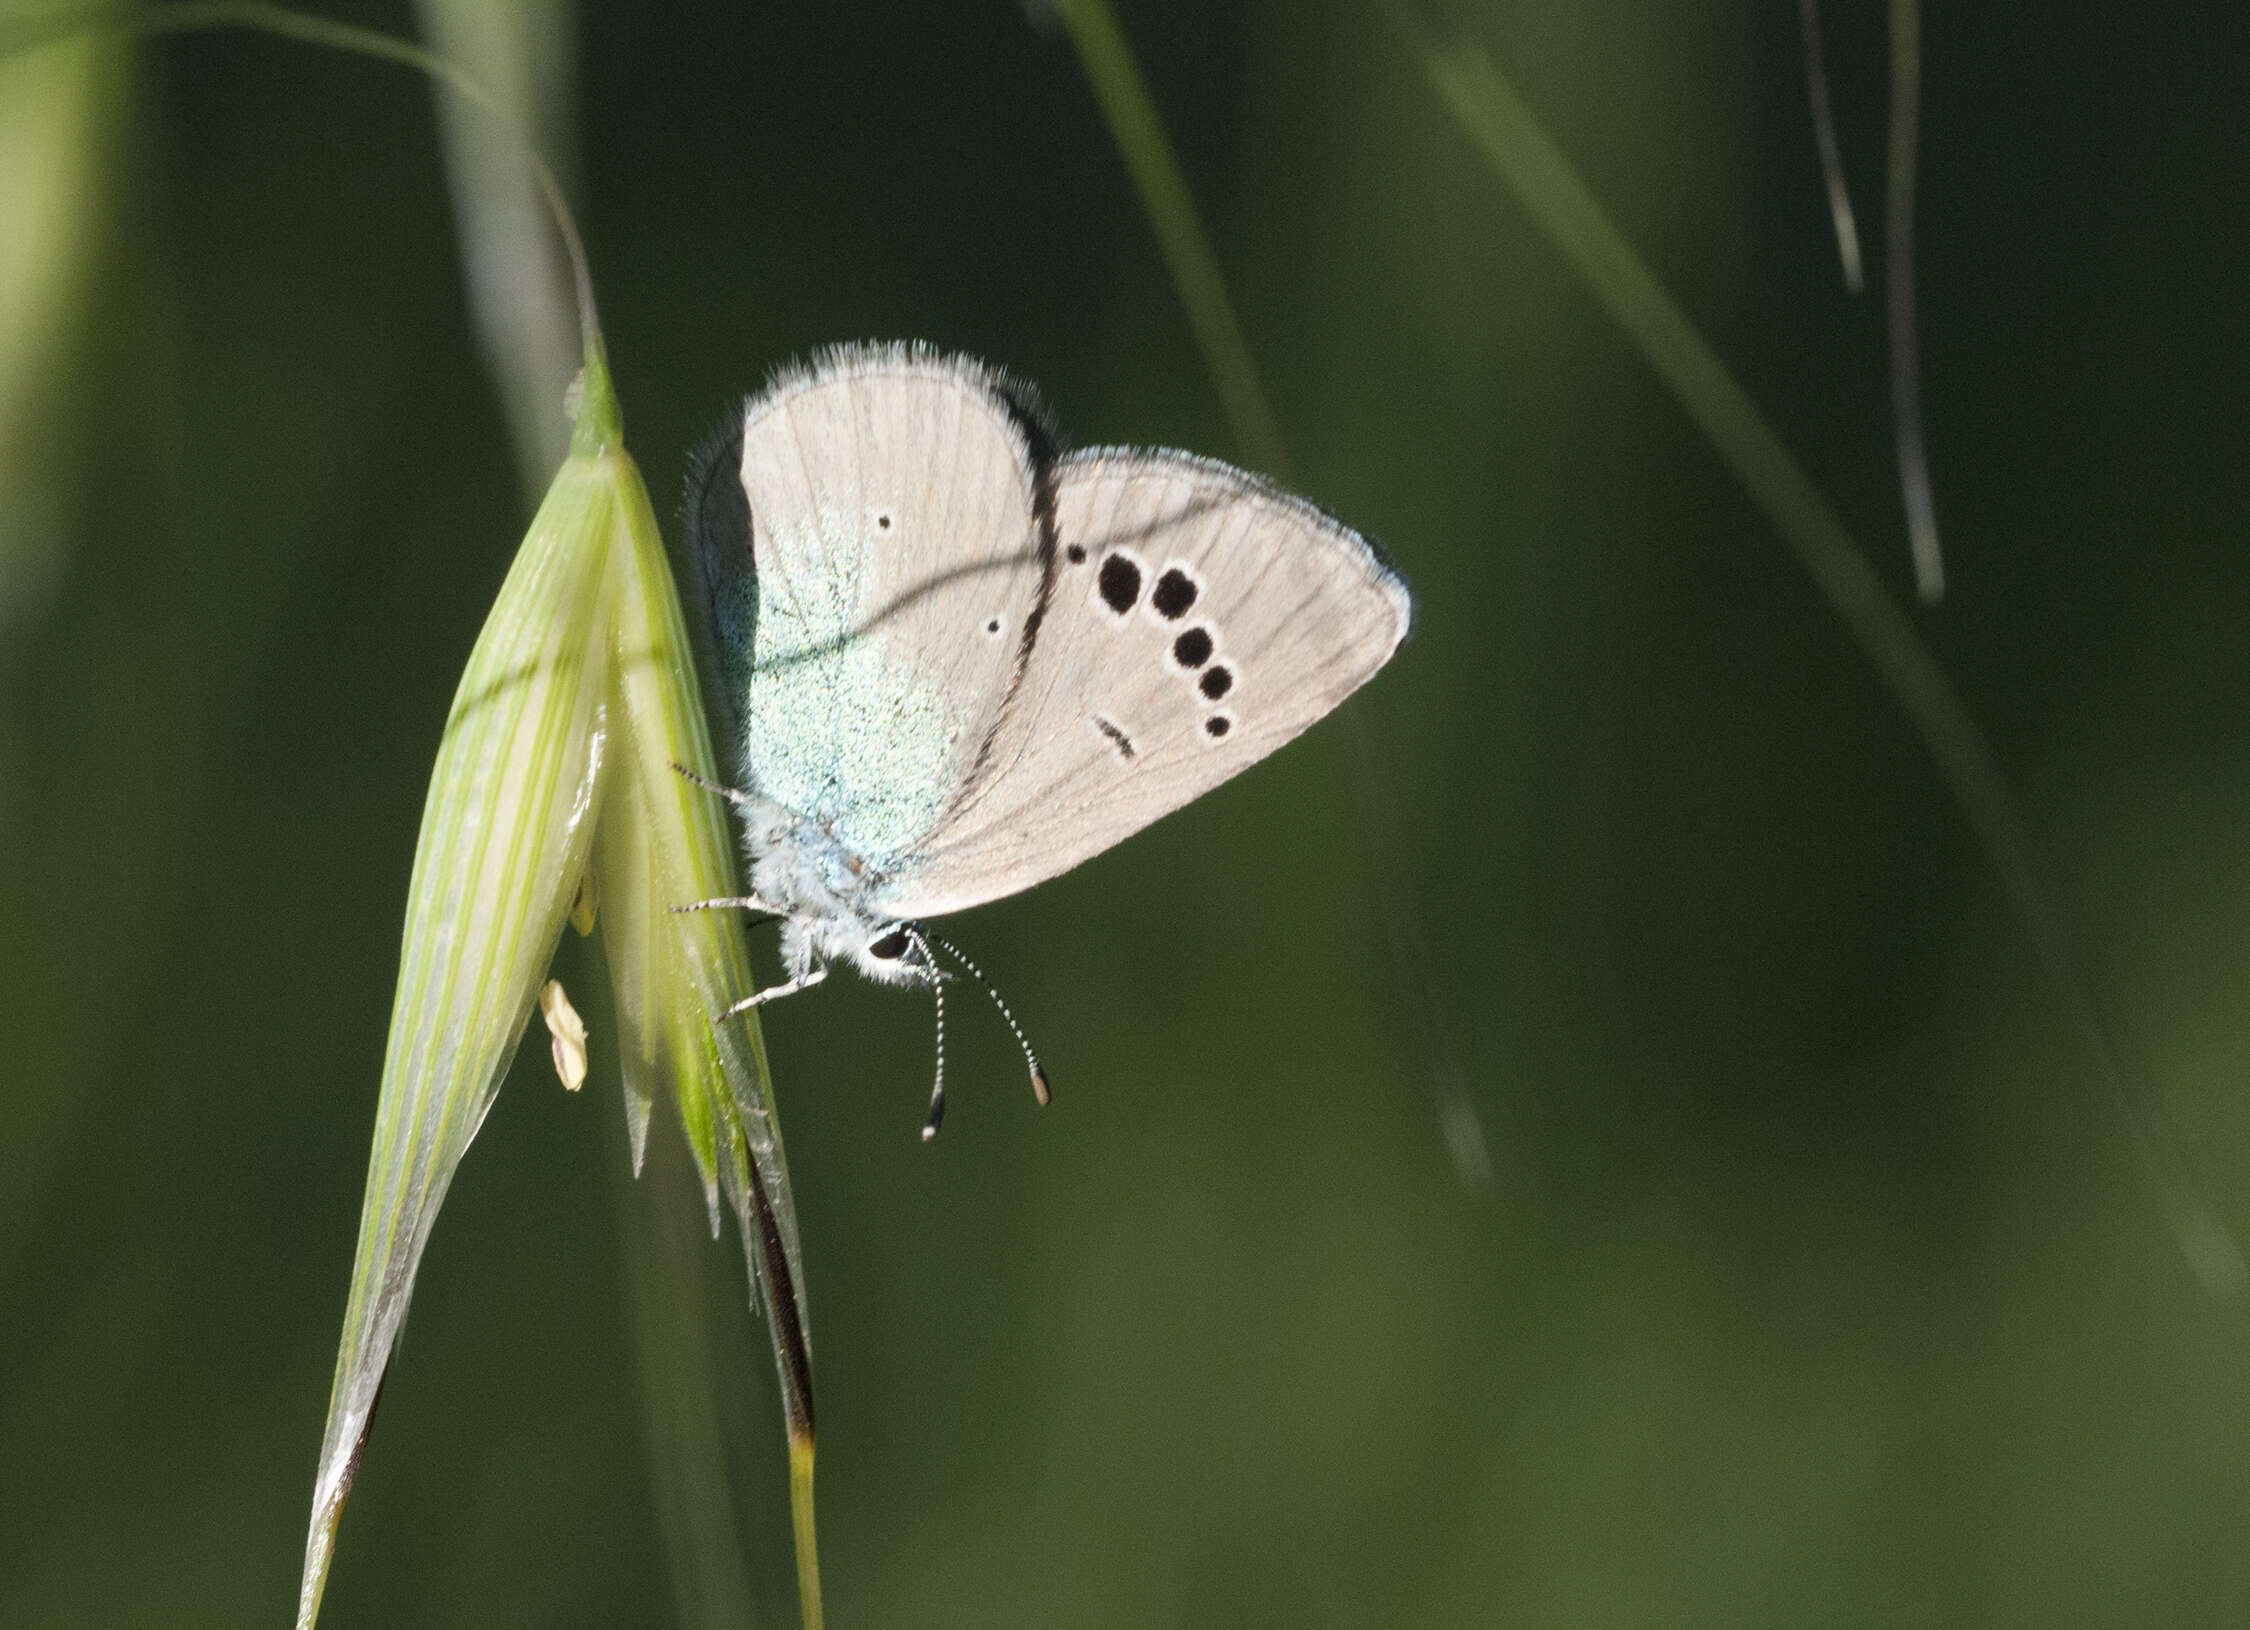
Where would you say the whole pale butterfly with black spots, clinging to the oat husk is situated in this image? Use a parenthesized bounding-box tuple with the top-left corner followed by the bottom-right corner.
(682, 344, 1413, 1137)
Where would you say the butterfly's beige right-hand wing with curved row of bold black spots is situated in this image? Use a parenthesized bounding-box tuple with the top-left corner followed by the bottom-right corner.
(873, 448, 1411, 916)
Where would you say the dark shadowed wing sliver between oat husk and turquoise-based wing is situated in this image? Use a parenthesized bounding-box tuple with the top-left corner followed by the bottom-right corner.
(673, 408, 758, 777)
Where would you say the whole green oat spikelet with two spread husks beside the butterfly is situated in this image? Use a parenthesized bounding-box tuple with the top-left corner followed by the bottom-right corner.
(297, 328, 819, 1630)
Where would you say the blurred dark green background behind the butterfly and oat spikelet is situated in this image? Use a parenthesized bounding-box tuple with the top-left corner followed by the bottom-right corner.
(0, 0, 2250, 1630)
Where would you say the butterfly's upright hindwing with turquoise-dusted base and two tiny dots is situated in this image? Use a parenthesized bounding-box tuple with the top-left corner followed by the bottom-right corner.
(740, 349, 1051, 878)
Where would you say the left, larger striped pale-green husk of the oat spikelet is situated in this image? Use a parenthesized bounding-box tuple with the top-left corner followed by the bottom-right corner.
(297, 407, 619, 1628)
